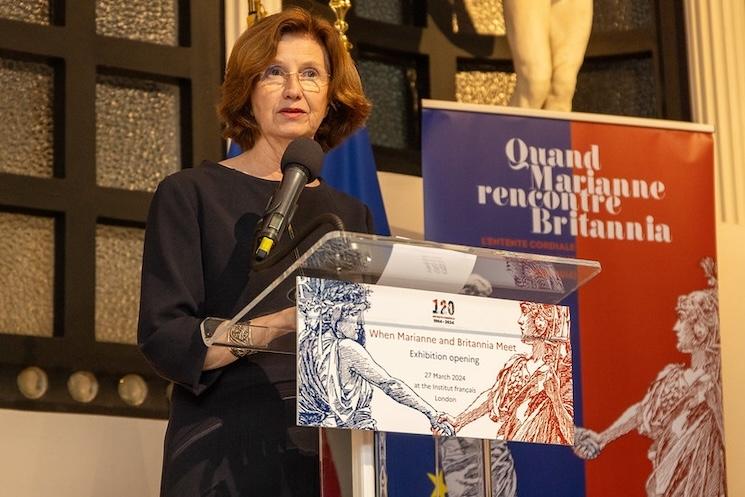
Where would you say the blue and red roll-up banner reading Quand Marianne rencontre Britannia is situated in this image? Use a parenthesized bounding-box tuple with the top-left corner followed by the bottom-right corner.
(389, 101, 725, 497)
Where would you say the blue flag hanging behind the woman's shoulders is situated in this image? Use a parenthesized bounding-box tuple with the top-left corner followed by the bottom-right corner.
(228, 128, 391, 235)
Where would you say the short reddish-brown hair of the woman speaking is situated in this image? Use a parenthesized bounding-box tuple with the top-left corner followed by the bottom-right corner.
(218, 7, 371, 150)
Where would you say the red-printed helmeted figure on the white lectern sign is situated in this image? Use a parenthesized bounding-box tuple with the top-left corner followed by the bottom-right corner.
(443, 302, 574, 444)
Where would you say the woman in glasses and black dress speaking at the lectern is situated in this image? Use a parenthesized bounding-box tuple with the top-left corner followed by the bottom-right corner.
(139, 9, 372, 497)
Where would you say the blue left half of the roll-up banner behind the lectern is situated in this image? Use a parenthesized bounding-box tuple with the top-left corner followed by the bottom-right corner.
(422, 105, 592, 497)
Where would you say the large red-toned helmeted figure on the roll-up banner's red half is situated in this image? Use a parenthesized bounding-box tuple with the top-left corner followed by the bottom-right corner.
(574, 258, 725, 497)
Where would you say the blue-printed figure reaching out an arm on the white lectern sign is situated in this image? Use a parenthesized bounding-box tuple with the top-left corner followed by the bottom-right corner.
(298, 279, 455, 435)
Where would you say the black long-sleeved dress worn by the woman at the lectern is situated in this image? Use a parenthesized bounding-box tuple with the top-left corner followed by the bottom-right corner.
(138, 162, 372, 497)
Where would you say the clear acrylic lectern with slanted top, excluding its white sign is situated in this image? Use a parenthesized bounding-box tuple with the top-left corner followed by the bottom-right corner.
(208, 231, 600, 497)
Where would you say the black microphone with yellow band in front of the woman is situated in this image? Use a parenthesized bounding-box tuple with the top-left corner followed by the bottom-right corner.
(254, 137, 323, 261)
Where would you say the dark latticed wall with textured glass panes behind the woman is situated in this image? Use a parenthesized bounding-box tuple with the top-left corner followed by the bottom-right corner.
(0, 0, 690, 417)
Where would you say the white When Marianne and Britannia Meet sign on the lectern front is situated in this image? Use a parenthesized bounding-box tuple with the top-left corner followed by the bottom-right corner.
(297, 277, 574, 444)
